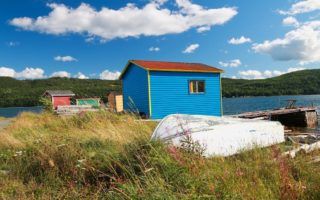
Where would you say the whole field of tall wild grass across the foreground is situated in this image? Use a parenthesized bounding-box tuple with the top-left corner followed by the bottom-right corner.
(0, 111, 320, 199)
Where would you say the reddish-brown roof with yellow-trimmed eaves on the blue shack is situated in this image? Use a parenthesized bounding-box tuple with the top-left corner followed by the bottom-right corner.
(120, 60, 223, 79)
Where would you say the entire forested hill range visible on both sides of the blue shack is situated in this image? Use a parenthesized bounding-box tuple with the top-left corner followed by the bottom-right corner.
(0, 69, 320, 107)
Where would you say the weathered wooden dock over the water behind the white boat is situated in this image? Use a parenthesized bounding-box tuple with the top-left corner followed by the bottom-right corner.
(234, 107, 318, 127)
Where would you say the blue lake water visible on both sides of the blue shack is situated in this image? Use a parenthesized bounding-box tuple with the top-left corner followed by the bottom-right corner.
(0, 95, 320, 117)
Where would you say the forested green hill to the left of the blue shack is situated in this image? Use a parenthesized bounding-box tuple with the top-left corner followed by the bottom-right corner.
(0, 77, 121, 107)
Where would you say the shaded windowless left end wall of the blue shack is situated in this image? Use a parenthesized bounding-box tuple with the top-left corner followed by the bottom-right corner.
(122, 64, 149, 116)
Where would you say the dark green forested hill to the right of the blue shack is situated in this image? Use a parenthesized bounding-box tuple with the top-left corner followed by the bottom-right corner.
(222, 69, 320, 97)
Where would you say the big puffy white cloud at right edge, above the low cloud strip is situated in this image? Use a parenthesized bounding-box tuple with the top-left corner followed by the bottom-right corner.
(252, 21, 320, 64)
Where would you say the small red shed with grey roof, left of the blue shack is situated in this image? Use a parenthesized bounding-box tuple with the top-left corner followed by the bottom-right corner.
(43, 90, 75, 110)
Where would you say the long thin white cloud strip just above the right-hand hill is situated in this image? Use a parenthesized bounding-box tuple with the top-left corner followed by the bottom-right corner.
(238, 67, 305, 79)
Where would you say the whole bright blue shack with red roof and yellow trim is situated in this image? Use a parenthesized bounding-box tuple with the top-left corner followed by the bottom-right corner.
(119, 60, 223, 119)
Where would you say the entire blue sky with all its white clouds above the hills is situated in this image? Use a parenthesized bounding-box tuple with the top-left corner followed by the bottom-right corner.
(0, 0, 320, 80)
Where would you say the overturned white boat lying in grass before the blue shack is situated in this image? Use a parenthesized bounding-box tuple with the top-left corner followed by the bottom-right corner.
(151, 114, 284, 157)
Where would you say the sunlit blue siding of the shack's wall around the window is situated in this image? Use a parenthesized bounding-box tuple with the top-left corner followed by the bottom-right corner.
(150, 71, 222, 119)
